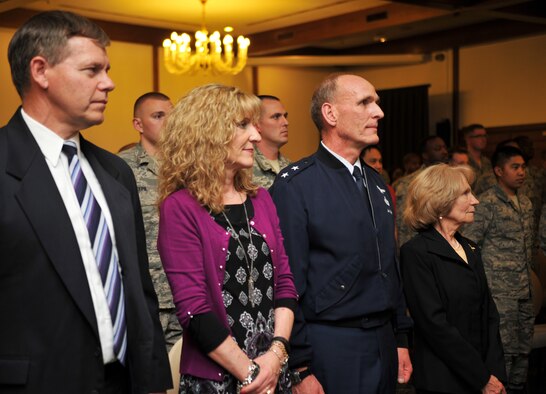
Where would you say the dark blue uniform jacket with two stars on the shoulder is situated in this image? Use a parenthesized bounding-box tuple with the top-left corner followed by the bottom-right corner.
(270, 145, 411, 366)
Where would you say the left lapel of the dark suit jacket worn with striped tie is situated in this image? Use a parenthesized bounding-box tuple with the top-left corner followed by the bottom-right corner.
(6, 112, 98, 335)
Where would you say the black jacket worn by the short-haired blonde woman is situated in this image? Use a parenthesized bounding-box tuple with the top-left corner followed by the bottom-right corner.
(400, 228, 506, 394)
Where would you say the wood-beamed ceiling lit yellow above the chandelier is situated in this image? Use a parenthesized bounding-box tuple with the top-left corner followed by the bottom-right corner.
(0, 0, 546, 57)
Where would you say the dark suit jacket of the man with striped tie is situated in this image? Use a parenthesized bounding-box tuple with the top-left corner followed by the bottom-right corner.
(0, 110, 172, 394)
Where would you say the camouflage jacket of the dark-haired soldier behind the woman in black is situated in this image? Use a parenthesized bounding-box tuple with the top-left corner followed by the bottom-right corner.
(462, 184, 533, 300)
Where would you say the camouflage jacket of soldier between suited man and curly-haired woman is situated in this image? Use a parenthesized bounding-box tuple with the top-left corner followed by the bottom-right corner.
(119, 144, 174, 309)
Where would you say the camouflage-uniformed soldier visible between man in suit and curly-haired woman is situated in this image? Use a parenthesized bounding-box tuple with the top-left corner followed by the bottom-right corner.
(119, 92, 182, 350)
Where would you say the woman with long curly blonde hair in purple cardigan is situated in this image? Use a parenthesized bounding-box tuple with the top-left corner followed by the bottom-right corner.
(158, 85, 297, 394)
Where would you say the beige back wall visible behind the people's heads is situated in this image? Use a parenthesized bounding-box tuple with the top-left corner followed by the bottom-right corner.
(0, 24, 546, 156)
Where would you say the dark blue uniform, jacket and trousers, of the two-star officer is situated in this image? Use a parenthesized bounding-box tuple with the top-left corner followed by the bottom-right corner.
(270, 144, 412, 393)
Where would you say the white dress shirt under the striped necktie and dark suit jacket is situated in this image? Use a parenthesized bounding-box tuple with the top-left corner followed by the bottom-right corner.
(21, 110, 117, 364)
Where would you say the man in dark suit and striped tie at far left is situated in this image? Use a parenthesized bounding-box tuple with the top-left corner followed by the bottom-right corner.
(0, 11, 172, 394)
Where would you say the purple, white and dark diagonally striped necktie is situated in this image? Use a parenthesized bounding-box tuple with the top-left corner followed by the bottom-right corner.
(63, 141, 127, 364)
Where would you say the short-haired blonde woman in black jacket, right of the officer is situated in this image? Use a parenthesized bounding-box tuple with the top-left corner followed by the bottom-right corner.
(400, 164, 506, 394)
